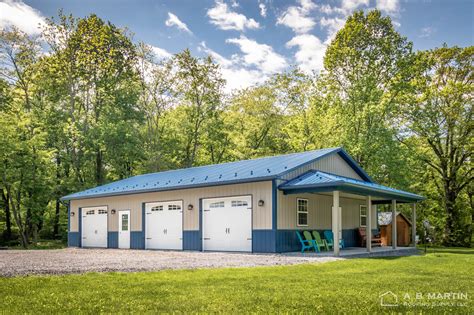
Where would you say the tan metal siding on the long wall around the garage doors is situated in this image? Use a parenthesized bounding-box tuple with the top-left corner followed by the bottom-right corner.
(71, 181, 272, 232)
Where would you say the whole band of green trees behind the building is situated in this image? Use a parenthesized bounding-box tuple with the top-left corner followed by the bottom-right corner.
(0, 10, 474, 246)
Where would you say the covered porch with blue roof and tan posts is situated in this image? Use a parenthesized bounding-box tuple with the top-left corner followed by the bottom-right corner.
(278, 170, 424, 256)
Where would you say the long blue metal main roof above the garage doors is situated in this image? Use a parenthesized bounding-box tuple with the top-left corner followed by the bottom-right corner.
(61, 148, 344, 200)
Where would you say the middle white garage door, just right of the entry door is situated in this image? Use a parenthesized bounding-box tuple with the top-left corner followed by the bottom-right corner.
(145, 201, 183, 249)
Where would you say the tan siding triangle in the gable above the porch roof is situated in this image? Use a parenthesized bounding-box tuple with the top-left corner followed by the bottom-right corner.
(282, 153, 362, 179)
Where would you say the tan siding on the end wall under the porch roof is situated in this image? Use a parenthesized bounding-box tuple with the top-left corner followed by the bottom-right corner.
(277, 191, 376, 230)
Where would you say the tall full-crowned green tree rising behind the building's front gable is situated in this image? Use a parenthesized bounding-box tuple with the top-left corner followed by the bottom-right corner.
(311, 10, 413, 187)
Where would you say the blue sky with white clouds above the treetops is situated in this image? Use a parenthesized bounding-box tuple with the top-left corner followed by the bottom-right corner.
(0, 0, 474, 90)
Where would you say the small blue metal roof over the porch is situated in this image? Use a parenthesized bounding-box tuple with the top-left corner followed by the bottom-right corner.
(278, 170, 425, 203)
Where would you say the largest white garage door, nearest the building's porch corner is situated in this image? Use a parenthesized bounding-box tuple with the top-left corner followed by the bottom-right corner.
(202, 196, 252, 252)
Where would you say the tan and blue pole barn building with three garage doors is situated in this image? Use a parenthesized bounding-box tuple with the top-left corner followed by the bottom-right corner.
(62, 148, 423, 255)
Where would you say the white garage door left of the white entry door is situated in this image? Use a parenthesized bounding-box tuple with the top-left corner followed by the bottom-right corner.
(81, 207, 107, 247)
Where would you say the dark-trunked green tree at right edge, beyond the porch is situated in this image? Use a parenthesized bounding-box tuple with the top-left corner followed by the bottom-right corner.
(401, 46, 474, 246)
